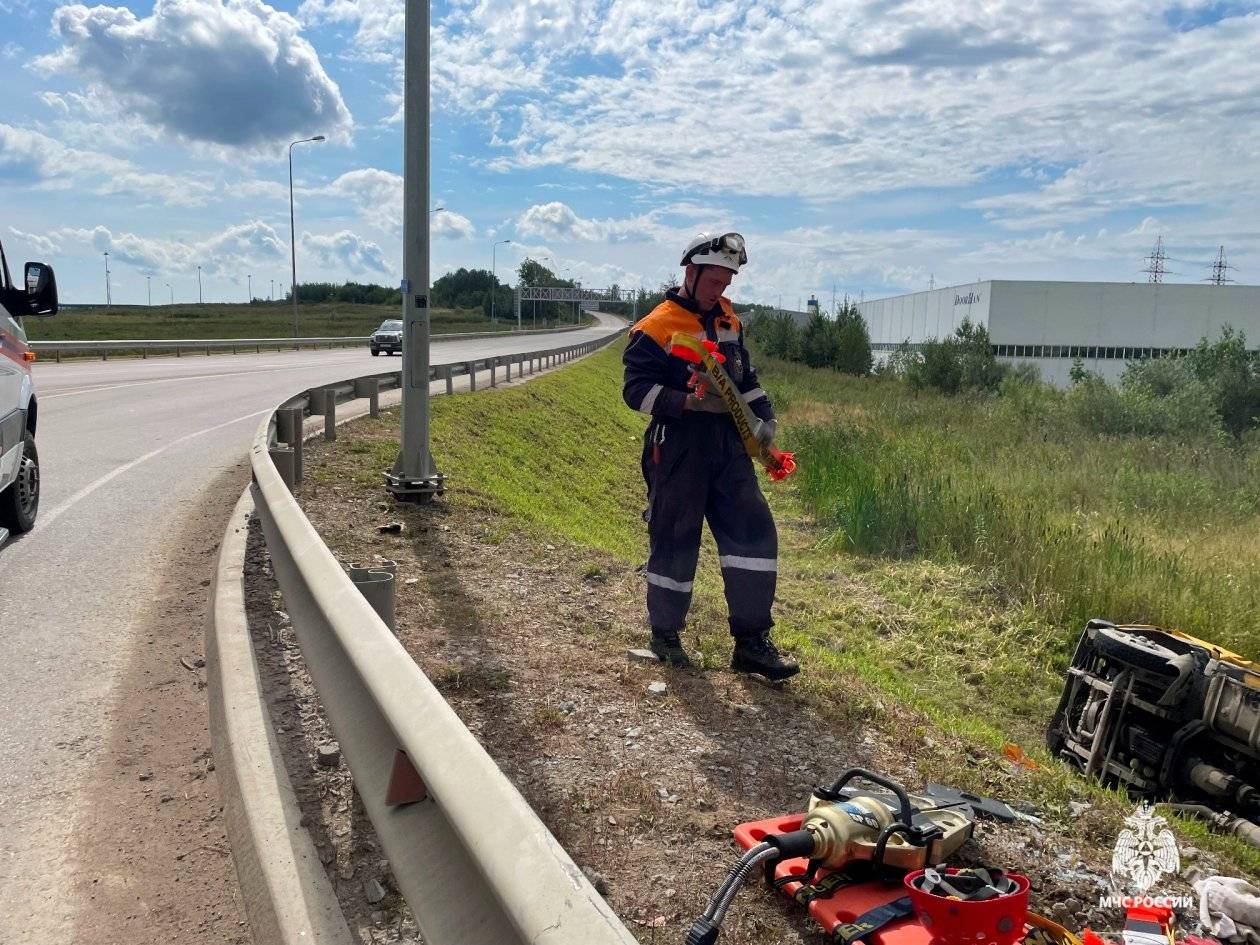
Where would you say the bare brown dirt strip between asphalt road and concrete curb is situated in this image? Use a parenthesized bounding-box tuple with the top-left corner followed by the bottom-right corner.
(74, 464, 251, 945)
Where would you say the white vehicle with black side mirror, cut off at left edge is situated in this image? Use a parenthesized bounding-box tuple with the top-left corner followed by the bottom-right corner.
(0, 236, 57, 544)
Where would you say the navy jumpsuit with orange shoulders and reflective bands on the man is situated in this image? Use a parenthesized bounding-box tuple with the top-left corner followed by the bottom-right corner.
(621, 291, 779, 638)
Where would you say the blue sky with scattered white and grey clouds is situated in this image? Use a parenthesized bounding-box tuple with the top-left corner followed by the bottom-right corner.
(0, 0, 1260, 307)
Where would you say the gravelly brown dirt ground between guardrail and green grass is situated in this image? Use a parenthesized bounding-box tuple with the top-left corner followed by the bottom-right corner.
(273, 408, 1219, 942)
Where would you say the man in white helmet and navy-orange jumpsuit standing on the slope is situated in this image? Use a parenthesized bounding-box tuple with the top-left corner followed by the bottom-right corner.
(622, 233, 800, 679)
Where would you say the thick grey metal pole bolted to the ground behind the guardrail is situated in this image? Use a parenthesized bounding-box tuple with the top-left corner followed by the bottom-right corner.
(386, 0, 445, 501)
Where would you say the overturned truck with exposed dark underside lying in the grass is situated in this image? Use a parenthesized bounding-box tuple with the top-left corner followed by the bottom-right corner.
(1046, 620, 1260, 847)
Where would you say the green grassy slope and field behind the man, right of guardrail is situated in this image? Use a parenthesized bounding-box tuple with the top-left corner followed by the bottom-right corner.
(335, 347, 1260, 872)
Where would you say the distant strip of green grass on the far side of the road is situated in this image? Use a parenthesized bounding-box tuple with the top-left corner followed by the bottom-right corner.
(25, 302, 515, 341)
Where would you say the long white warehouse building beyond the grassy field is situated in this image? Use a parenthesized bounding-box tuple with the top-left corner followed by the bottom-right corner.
(858, 280, 1260, 387)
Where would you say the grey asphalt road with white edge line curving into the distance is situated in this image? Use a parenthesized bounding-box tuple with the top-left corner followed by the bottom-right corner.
(0, 316, 620, 945)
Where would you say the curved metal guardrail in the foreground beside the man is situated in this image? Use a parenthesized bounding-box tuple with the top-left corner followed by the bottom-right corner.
(251, 330, 635, 945)
